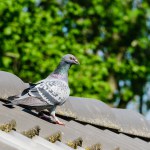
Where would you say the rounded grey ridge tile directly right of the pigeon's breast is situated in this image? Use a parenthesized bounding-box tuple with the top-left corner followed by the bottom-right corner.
(57, 97, 118, 129)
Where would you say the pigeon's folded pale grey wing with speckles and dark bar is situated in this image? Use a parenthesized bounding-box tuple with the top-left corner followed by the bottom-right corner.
(28, 79, 70, 105)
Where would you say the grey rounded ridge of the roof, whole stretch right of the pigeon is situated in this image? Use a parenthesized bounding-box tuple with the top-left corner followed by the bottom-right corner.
(57, 97, 150, 139)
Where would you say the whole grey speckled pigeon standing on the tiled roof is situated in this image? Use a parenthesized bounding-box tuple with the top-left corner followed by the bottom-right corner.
(6, 54, 79, 125)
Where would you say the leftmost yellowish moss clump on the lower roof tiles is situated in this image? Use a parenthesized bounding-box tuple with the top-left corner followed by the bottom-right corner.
(0, 120, 16, 132)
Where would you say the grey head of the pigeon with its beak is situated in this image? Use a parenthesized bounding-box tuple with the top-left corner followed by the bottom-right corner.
(62, 54, 80, 65)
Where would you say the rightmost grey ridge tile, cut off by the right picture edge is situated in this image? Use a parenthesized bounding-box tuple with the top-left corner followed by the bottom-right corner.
(112, 108, 150, 138)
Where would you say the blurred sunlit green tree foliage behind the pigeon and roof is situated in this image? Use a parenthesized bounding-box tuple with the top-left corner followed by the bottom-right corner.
(0, 0, 150, 112)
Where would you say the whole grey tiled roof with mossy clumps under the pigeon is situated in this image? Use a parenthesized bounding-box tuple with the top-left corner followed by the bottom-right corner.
(0, 72, 150, 150)
